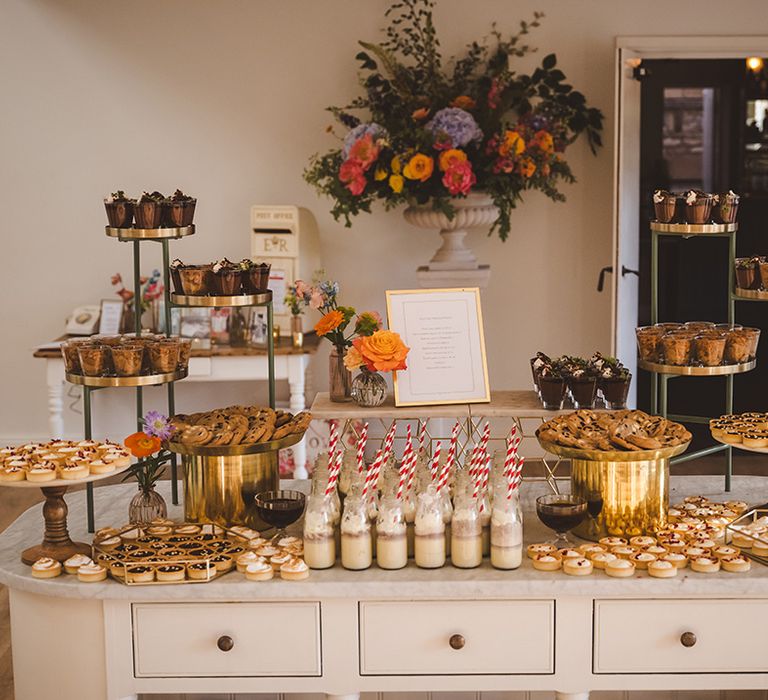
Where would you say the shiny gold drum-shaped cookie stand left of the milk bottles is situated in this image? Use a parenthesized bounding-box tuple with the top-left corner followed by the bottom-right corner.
(167, 433, 304, 530)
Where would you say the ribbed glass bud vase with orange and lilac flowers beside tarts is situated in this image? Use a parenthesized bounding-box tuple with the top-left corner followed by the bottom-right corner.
(123, 411, 174, 523)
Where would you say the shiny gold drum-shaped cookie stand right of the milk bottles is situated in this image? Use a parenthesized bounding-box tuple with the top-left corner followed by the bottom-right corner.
(539, 438, 690, 541)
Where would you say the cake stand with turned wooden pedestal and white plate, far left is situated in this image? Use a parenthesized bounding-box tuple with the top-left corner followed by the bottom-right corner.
(0, 464, 131, 566)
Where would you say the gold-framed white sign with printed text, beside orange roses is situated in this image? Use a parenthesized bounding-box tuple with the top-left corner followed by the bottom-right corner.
(387, 288, 491, 406)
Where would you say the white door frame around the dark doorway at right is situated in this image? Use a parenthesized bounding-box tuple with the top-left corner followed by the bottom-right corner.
(611, 36, 768, 405)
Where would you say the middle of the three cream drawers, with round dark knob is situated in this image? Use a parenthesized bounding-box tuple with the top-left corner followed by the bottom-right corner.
(360, 600, 555, 676)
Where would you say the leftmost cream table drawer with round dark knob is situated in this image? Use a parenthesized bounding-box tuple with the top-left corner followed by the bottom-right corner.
(133, 603, 322, 678)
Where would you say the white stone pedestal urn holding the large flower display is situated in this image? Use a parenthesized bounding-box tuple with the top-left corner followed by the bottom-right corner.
(403, 193, 499, 287)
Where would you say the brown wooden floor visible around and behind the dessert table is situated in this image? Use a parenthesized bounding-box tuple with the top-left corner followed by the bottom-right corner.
(0, 456, 767, 700)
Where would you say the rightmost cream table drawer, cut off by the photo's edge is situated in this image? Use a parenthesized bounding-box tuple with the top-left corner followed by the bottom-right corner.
(594, 600, 768, 673)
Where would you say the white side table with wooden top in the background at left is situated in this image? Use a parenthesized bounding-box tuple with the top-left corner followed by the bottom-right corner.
(34, 334, 319, 476)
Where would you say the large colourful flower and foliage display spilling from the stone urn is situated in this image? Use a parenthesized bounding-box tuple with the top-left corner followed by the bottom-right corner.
(304, 0, 603, 240)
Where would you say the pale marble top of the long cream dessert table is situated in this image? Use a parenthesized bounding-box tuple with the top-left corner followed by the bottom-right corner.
(0, 476, 768, 601)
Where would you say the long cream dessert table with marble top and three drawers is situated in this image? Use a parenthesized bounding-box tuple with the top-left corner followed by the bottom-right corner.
(0, 476, 768, 700)
